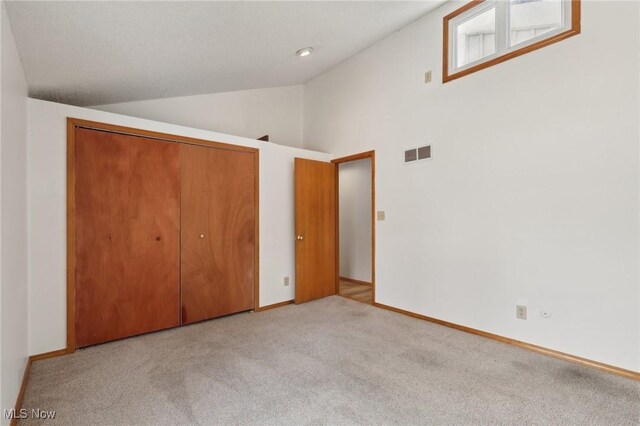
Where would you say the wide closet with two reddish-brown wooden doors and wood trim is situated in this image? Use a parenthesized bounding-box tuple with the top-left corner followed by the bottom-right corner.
(67, 119, 258, 350)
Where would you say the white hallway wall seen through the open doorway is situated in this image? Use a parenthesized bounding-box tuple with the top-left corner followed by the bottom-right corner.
(338, 159, 371, 282)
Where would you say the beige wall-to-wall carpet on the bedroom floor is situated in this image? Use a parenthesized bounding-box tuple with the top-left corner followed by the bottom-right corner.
(21, 296, 640, 425)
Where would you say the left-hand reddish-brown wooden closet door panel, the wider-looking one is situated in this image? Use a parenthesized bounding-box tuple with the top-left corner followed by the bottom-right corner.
(74, 128, 180, 347)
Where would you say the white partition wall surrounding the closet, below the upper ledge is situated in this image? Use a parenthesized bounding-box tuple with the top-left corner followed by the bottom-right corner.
(28, 99, 329, 354)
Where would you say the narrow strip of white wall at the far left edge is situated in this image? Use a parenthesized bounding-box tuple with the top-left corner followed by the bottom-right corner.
(0, 2, 28, 424)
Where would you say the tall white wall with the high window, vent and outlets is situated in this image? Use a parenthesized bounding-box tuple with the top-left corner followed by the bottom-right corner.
(304, 1, 640, 371)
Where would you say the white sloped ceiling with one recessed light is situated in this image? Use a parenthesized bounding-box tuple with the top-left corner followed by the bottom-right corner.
(7, 0, 444, 105)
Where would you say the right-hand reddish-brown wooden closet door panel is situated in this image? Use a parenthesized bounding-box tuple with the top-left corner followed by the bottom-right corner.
(181, 145, 257, 324)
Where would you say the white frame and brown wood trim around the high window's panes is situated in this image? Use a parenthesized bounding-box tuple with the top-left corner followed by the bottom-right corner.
(443, 0, 580, 82)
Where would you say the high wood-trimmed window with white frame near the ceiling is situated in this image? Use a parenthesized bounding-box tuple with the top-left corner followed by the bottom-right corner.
(442, 0, 580, 82)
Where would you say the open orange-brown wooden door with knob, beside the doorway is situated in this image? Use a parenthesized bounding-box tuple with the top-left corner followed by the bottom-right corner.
(295, 158, 337, 303)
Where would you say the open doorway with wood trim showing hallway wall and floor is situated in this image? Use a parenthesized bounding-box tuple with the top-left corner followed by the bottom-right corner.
(332, 151, 375, 304)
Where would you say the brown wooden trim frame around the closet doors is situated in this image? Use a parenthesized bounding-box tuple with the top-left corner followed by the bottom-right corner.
(66, 117, 260, 353)
